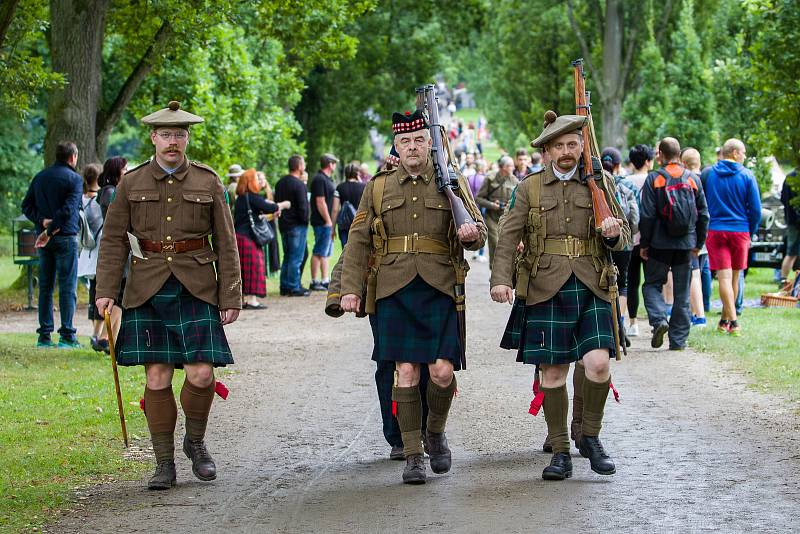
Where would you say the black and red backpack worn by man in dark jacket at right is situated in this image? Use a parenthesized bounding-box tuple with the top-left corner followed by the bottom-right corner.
(653, 169, 697, 237)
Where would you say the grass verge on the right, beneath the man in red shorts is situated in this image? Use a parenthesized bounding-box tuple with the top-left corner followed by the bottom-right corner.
(689, 269, 800, 403)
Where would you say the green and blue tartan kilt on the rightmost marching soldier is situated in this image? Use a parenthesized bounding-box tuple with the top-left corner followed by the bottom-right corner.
(500, 274, 614, 365)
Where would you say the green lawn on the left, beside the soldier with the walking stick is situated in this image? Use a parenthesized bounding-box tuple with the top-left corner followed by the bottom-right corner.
(0, 334, 151, 532)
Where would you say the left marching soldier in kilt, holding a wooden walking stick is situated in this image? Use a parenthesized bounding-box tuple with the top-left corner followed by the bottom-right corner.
(96, 102, 242, 490)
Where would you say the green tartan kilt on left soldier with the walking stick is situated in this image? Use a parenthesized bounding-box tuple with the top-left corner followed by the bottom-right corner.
(115, 276, 233, 369)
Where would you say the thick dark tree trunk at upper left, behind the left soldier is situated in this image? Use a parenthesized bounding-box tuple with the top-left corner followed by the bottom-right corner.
(44, 0, 110, 166)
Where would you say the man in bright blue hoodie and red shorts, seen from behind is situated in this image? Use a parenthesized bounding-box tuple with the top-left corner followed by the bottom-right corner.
(705, 139, 761, 336)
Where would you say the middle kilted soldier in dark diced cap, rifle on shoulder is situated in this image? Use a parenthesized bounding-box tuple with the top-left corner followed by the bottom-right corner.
(341, 111, 486, 484)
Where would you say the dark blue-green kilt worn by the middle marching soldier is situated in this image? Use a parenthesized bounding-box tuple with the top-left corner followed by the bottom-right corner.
(370, 276, 461, 371)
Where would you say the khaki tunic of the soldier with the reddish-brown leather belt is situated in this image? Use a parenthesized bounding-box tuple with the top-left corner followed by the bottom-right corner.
(97, 158, 242, 309)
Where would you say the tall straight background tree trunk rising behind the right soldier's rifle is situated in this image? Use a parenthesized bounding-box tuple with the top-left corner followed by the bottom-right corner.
(600, 0, 625, 148)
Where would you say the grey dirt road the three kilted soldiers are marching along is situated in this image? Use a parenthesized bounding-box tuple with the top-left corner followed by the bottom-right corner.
(25, 264, 800, 533)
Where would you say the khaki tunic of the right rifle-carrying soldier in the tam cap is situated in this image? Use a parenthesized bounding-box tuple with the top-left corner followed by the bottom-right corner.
(491, 164, 631, 306)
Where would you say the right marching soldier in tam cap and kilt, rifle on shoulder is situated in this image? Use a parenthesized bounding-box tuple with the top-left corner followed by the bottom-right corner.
(490, 111, 630, 480)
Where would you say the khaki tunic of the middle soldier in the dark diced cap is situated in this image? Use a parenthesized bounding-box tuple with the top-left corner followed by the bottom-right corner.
(341, 159, 486, 299)
